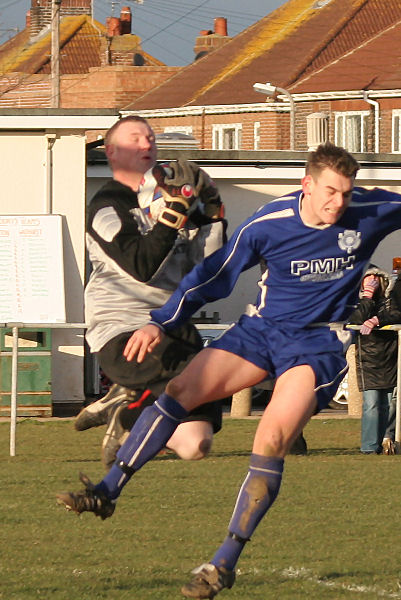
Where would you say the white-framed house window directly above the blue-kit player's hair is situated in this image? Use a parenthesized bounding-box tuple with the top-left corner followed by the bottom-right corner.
(335, 111, 369, 152)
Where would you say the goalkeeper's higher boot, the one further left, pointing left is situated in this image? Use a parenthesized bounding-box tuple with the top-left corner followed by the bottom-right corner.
(74, 383, 136, 431)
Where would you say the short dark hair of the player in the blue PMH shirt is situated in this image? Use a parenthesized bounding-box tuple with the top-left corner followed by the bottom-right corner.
(305, 142, 359, 177)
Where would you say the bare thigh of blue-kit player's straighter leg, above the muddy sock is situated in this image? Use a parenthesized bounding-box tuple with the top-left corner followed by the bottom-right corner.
(253, 365, 317, 456)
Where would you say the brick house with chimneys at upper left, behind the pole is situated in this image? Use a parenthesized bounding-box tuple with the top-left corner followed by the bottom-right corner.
(0, 0, 182, 108)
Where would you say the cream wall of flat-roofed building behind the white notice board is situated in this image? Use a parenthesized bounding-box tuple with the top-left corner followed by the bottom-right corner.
(0, 111, 118, 403)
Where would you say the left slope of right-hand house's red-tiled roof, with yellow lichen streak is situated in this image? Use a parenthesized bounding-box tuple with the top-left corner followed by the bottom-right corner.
(127, 0, 366, 110)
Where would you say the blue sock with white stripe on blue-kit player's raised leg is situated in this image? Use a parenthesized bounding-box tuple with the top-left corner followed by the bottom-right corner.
(96, 393, 188, 500)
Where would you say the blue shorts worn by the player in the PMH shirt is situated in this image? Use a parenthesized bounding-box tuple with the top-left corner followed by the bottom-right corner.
(209, 315, 351, 411)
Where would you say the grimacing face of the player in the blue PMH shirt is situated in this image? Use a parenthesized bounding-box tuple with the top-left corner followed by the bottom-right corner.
(301, 168, 354, 226)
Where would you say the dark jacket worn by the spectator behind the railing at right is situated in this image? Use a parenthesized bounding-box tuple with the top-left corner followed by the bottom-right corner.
(349, 268, 401, 392)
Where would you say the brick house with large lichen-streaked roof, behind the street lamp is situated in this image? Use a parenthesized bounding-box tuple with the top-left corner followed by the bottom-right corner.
(122, 0, 401, 152)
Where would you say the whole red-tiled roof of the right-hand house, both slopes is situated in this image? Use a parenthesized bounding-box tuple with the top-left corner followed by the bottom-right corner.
(126, 0, 401, 110)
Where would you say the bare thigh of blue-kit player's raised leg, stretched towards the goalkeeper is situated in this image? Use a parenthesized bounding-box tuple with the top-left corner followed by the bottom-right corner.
(167, 348, 266, 410)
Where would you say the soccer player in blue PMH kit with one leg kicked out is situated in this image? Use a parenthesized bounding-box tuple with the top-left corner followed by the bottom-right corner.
(58, 143, 401, 599)
